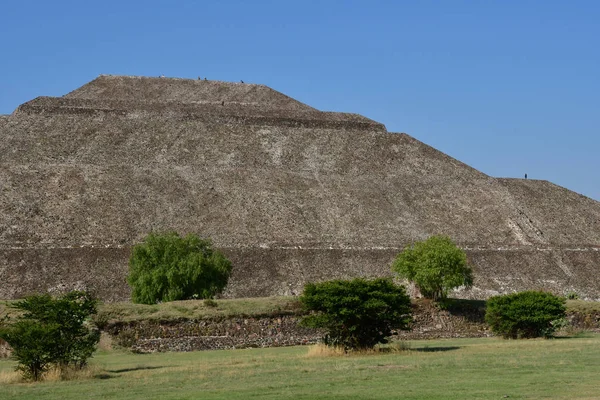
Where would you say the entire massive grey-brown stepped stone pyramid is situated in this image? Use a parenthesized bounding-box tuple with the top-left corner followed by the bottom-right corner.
(0, 75, 600, 301)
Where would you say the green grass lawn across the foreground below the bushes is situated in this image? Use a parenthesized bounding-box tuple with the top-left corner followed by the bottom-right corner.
(0, 334, 600, 400)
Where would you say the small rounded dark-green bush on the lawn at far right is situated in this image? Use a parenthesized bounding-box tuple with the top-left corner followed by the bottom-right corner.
(485, 291, 566, 339)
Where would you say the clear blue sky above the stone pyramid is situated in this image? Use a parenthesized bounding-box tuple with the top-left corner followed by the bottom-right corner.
(0, 0, 600, 200)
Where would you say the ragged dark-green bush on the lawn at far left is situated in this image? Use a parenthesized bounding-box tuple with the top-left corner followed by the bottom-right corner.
(0, 291, 100, 380)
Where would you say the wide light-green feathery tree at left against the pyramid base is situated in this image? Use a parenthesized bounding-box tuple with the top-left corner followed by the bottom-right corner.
(127, 232, 231, 304)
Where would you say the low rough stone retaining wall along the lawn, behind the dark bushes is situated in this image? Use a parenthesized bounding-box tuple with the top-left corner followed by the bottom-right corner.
(105, 301, 600, 353)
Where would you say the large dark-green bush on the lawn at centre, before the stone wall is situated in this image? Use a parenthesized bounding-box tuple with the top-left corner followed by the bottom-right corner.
(300, 278, 411, 350)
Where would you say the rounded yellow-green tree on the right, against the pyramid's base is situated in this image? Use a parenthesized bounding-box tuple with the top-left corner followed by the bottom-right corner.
(392, 236, 473, 300)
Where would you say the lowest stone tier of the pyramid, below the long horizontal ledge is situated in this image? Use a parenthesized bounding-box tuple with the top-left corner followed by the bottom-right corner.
(0, 246, 600, 302)
